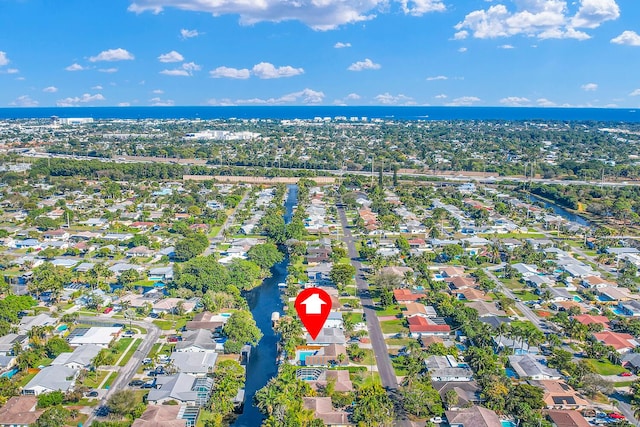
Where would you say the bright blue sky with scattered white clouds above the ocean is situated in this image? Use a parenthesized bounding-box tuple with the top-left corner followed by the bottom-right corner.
(0, 0, 640, 108)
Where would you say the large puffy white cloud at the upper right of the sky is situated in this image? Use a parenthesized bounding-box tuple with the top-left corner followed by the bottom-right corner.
(454, 0, 608, 40)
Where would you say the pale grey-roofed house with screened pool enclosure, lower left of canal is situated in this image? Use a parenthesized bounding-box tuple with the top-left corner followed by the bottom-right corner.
(147, 373, 213, 406)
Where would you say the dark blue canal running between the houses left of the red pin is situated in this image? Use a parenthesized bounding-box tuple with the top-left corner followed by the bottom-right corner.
(233, 185, 298, 427)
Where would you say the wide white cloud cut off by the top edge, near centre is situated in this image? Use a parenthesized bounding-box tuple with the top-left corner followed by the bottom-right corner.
(129, 0, 445, 30)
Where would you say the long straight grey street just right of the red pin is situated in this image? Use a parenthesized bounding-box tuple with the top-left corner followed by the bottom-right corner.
(338, 204, 411, 426)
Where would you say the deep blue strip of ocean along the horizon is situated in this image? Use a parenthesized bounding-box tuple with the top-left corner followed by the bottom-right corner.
(0, 106, 640, 123)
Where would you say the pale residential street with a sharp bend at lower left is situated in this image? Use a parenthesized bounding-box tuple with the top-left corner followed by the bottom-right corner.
(78, 316, 160, 426)
